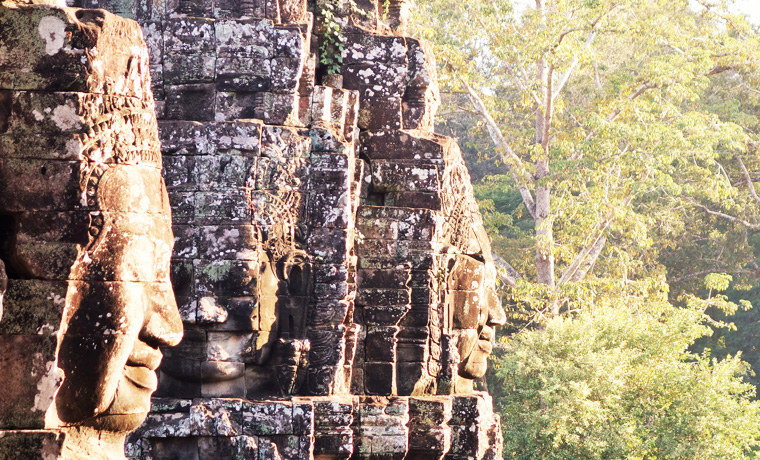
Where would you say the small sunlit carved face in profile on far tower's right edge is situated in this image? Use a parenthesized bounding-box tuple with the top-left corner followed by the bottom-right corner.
(447, 254, 506, 379)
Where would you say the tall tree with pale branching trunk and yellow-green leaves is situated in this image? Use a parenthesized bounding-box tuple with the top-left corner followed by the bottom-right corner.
(418, 0, 760, 321)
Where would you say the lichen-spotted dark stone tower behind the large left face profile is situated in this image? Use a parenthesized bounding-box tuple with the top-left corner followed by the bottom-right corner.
(0, 0, 504, 460)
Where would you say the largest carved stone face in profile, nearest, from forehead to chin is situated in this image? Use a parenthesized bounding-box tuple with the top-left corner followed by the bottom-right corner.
(56, 165, 182, 432)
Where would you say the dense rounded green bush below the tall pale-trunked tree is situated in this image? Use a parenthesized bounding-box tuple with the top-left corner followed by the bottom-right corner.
(491, 296, 760, 460)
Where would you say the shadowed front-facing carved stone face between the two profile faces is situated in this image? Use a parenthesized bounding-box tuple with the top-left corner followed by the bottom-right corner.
(161, 241, 311, 397)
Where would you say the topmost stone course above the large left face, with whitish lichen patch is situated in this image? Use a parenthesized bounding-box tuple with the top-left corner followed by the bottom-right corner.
(0, 5, 150, 95)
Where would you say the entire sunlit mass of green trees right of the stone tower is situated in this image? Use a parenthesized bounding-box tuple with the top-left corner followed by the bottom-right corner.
(417, 0, 760, 459)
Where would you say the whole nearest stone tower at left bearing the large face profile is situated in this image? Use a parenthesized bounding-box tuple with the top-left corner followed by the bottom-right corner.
(0, 2, 182, 460)
